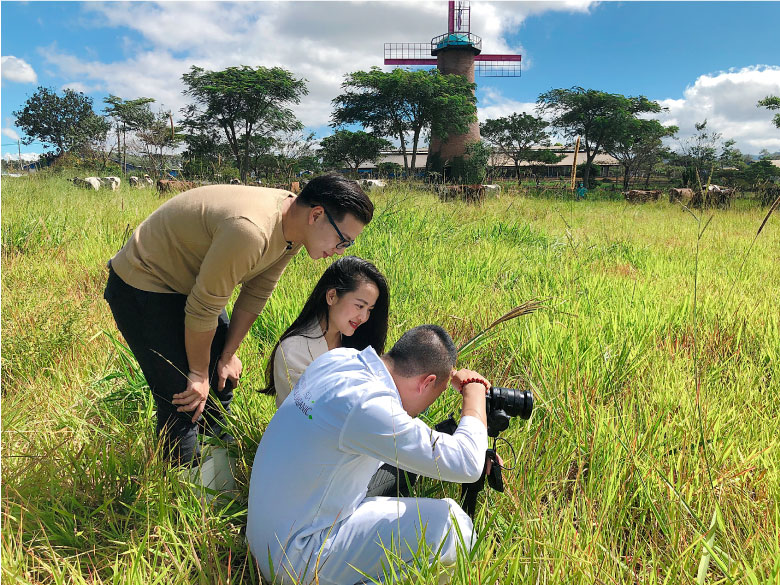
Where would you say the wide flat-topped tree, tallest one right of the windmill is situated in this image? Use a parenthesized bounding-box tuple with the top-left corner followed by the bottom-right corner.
(537, 87, 661, 184)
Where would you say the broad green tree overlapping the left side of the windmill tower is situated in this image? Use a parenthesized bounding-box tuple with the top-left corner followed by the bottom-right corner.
(331, 67, 476, 173)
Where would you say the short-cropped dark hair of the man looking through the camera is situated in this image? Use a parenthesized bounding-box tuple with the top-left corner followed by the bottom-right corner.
(386, 325, 458, 382)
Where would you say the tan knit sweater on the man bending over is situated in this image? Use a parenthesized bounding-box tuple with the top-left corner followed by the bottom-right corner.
(111, 185, 301, 331)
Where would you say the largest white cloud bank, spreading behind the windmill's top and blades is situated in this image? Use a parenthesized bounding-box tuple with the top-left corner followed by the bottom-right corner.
(42, 0, 592, 127)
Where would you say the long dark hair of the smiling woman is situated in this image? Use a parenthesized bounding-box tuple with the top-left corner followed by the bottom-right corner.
(262, 256, 390, 394)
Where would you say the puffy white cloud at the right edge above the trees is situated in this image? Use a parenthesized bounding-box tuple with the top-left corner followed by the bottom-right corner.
(658, 65, 780, 154)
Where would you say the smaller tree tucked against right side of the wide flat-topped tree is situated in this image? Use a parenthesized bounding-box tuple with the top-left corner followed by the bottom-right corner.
(604, 115, 679, 190)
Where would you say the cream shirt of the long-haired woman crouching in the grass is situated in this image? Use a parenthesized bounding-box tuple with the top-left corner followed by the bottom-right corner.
(274, 321, 328, 408)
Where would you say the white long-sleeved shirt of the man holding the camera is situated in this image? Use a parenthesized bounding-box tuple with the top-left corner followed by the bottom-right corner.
(247, 347, 488, 576)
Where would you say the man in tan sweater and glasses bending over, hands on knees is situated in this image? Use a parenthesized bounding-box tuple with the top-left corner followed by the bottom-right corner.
(104, 175, 374, 464)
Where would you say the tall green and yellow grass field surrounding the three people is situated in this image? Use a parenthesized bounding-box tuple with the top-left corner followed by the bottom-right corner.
(1, 176, 780, 585)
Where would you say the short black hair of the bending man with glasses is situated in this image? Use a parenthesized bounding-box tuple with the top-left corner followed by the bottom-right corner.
(296, 173, 374, 225)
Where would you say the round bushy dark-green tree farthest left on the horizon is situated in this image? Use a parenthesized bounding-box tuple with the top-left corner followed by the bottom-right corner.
(13, 87, 110, 156)
